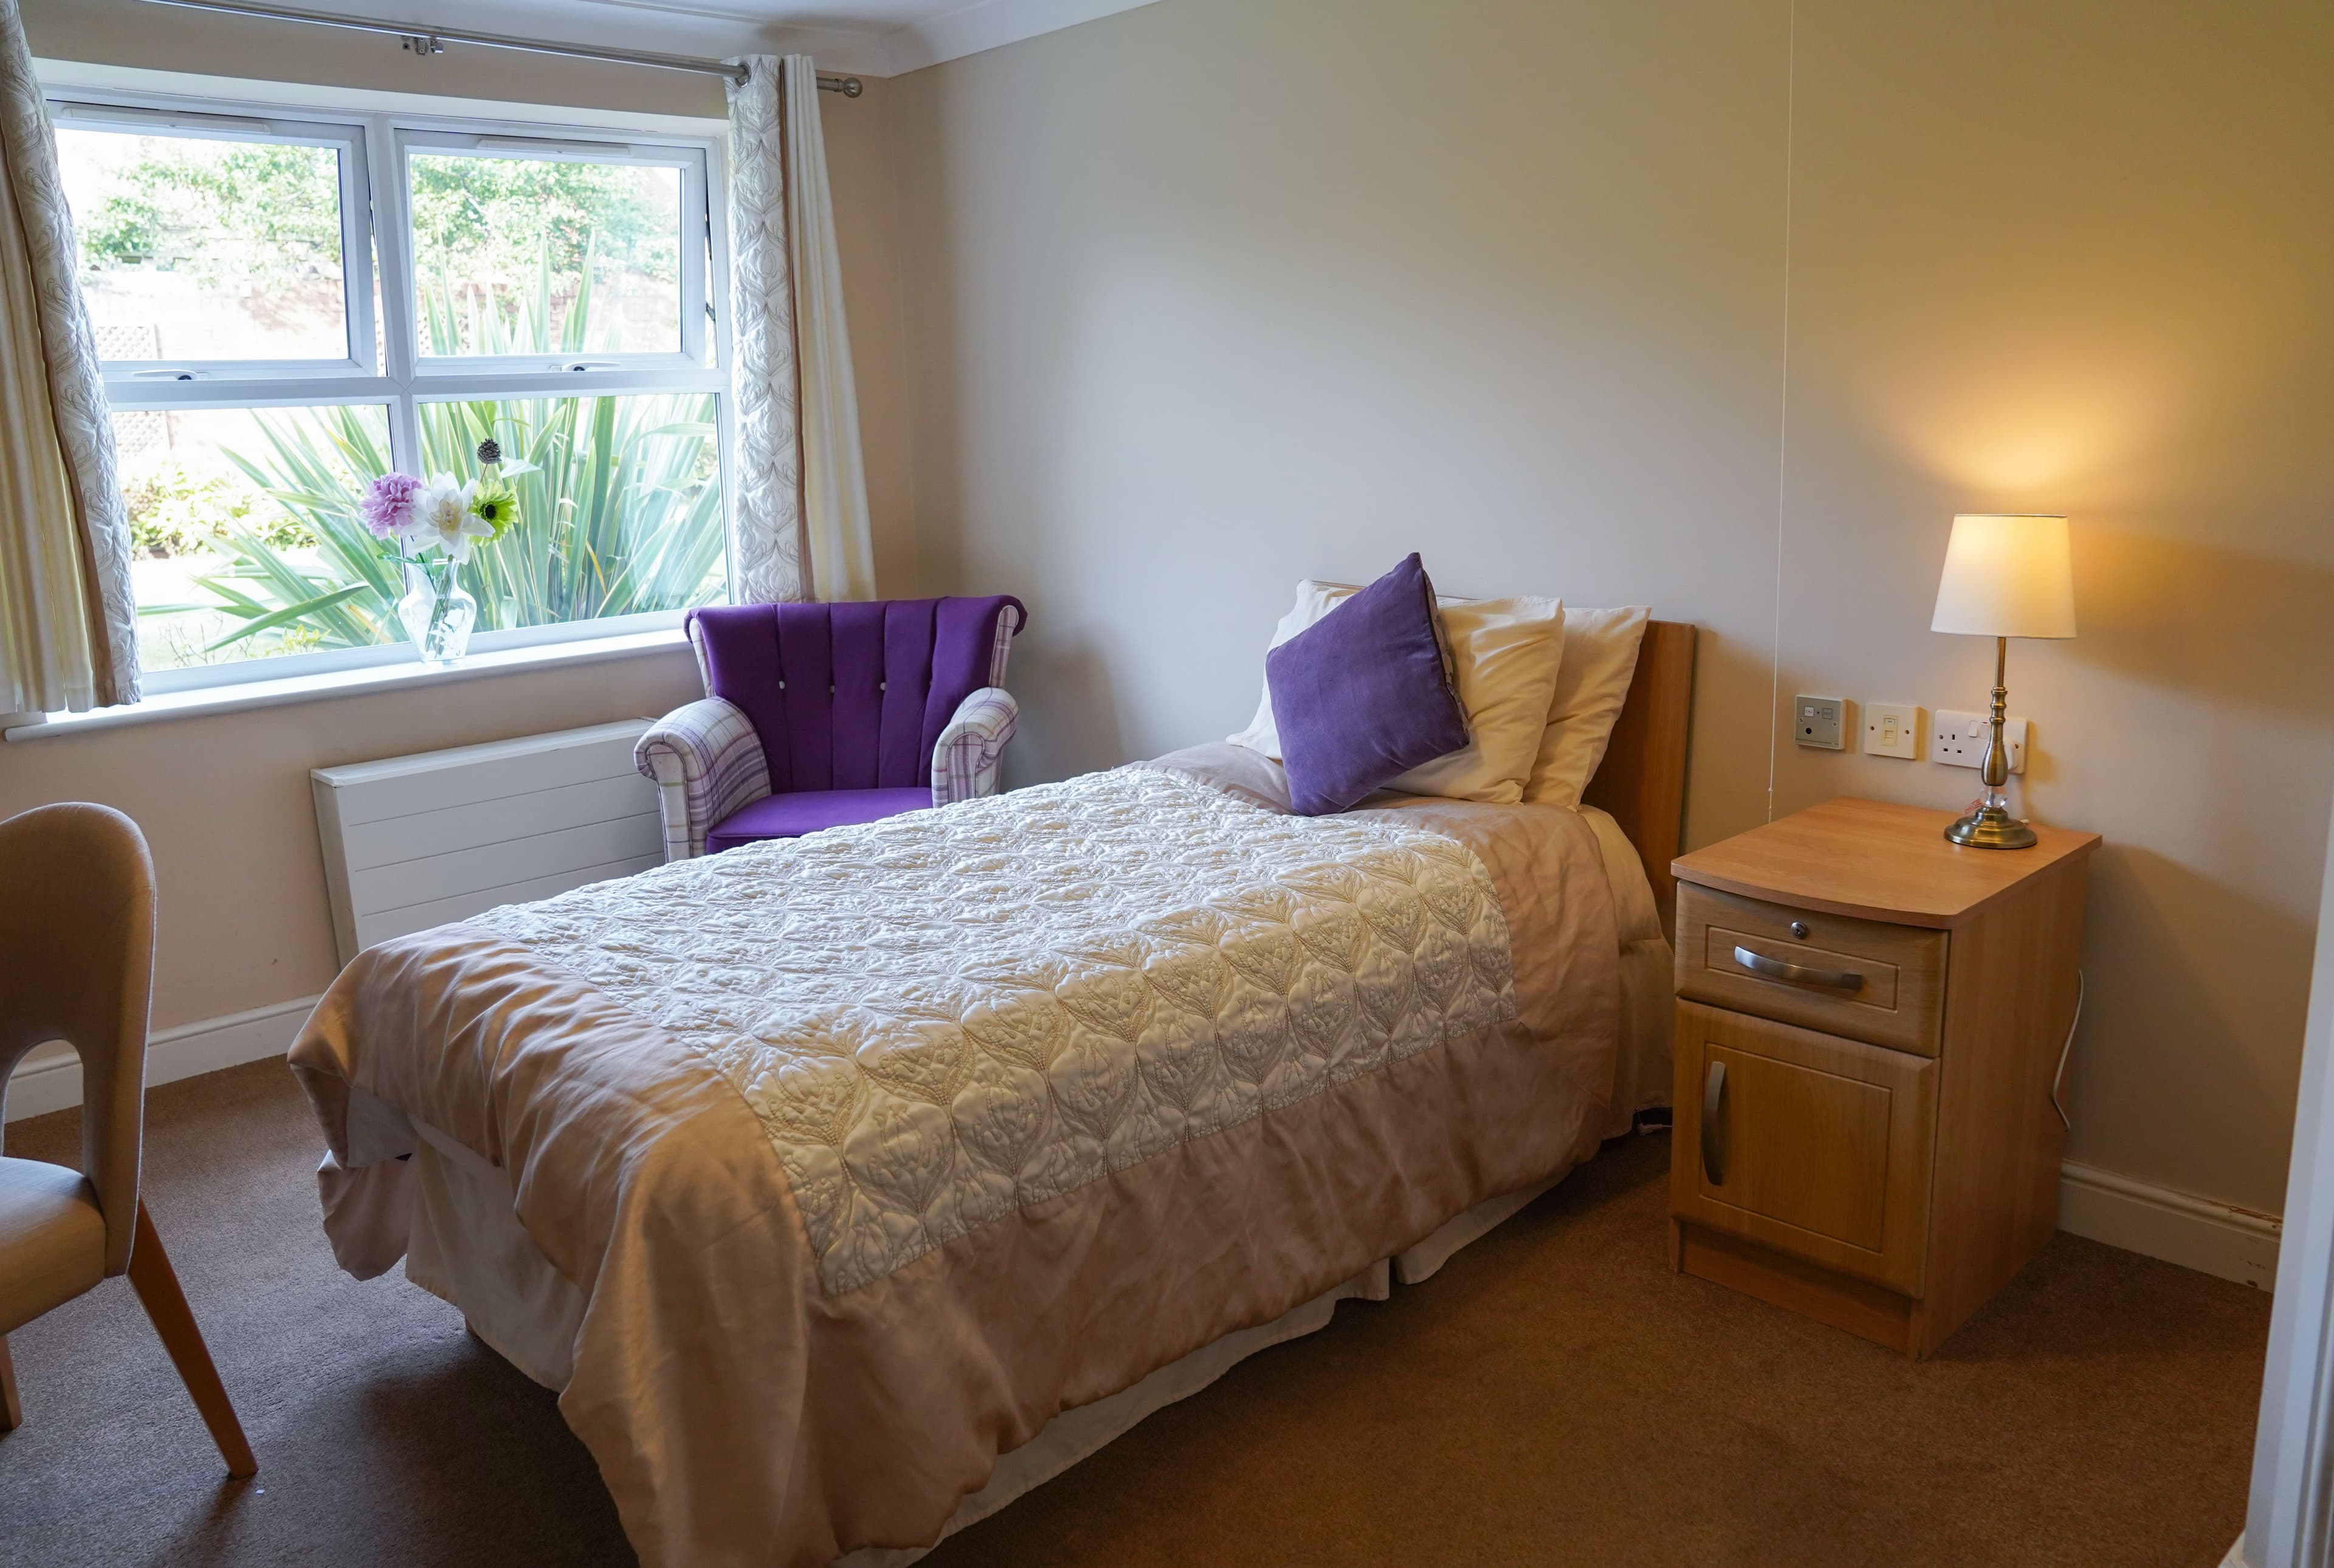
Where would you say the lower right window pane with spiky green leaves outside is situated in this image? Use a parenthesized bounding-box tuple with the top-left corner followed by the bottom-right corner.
(420, 394, 726, 632)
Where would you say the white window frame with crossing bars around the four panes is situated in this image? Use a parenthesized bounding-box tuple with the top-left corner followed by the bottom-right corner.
(47, 86, 735, 695)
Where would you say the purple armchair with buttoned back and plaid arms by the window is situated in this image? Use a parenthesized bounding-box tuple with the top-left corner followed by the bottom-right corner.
(633, 595, 1027, 861)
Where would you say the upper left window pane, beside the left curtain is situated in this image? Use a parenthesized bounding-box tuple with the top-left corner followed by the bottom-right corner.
(56, 126, 348, 362)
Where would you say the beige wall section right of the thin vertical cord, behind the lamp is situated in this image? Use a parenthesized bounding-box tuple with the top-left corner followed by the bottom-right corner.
(1776, 0, 2334, 1211)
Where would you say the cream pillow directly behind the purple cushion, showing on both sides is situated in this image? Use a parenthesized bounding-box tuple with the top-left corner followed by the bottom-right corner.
(1228, 579, 1564, 805)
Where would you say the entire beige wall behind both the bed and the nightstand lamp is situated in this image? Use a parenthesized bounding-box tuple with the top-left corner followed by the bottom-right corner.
(892, 0, 2334, 1211)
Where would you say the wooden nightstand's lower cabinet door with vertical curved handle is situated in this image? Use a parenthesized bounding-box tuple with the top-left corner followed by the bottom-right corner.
(1671, 1001, 1937, 1295)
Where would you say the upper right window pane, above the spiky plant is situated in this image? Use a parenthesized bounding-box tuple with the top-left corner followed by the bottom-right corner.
(408, 150, 681, 355)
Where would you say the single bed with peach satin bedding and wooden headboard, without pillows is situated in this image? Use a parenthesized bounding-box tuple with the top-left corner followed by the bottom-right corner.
(292, 623, 1695, 1568)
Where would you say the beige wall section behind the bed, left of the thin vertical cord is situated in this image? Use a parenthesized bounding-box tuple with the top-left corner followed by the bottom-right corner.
(894, 0, 1786, 833)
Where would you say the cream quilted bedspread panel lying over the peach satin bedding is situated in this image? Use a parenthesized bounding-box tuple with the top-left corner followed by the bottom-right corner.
(472, 768, 1515, 1295)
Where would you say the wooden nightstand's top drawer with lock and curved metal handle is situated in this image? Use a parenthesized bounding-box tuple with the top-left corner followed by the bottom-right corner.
(1678, 882, 1947, 1057)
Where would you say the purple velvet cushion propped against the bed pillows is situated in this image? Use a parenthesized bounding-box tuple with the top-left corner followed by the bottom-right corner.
(1265, 553, 1468, 817)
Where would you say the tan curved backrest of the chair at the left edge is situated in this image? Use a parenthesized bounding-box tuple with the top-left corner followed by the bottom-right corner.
(0, 803, 154, 1274)
